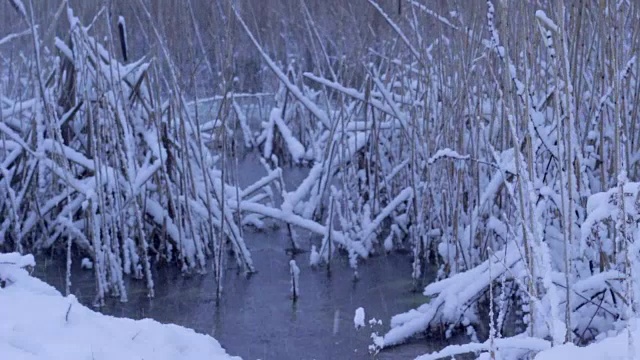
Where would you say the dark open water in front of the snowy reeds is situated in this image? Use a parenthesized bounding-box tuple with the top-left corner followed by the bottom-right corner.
(36, 231, 460, 360)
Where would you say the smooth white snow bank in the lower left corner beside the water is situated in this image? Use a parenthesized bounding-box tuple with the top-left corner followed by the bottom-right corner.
(0, 254, 240, 360)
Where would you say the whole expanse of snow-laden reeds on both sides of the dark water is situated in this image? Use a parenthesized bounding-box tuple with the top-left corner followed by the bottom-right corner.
(0, 0, 640, 359)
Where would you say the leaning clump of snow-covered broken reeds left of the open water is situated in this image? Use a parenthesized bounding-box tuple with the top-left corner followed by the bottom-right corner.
(0, 9, 270, 304)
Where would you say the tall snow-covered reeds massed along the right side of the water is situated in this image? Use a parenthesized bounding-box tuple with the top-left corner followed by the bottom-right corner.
(235, 0, 640, 356)
